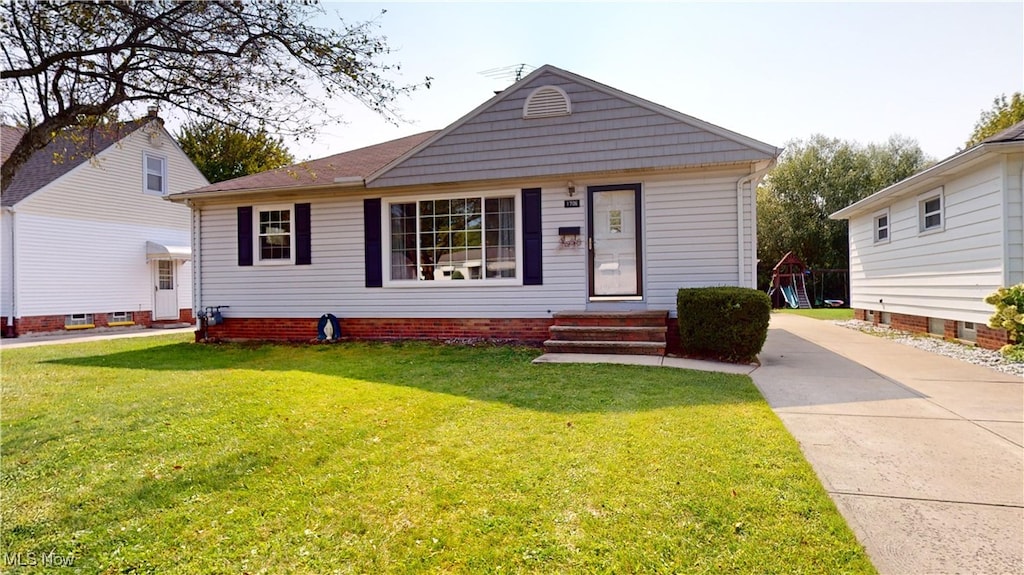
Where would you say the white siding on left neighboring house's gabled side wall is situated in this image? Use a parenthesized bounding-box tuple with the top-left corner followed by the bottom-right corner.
(3, 123, 207, 317)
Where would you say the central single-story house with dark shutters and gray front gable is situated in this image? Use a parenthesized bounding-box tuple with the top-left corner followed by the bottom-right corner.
(170, 65, 780, 349)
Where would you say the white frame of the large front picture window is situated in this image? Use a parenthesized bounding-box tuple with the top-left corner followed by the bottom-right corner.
(381, 189, 523, 290)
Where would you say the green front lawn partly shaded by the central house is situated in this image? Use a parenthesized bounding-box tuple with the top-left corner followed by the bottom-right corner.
(0, 336, 873, 574)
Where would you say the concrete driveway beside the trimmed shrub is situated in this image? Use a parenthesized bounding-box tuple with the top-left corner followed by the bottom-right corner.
(751, 314, 1024, 574)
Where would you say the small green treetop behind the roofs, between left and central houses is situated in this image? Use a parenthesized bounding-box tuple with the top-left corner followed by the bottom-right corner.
(177, 120, 295, 183)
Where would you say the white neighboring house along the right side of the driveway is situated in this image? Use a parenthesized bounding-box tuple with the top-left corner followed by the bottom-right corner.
(831, 122, 1024, 348)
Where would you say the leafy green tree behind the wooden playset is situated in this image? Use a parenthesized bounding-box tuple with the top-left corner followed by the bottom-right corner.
(758, 135, 929, 278)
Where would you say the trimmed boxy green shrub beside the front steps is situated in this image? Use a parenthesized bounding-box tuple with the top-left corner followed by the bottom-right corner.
(676, 286, 771, 362)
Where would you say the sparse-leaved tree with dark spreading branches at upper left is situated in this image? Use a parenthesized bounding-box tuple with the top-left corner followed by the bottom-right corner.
(0, 0, 430, 187)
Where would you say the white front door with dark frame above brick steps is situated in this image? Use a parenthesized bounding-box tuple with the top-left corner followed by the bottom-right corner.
(587, 184, 643, 301)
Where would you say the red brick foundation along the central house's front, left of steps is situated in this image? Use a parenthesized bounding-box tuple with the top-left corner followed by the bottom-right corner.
(196, 317, 554, 345)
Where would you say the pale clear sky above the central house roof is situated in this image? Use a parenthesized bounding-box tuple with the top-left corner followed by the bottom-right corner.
(280, 2, 1024, 163)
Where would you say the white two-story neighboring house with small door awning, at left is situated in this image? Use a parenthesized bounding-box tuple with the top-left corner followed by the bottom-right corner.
(0, 110, 209, 337)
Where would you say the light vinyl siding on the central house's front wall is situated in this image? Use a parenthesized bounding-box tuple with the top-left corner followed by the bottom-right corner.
(193, 171, 754, 318)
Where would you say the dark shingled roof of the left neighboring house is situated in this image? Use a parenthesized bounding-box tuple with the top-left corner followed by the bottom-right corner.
(0, 117, 150, 206)
